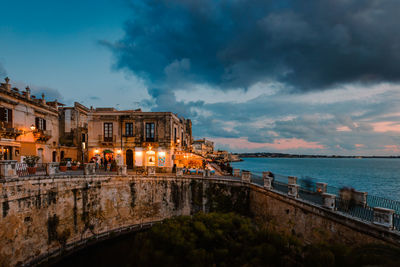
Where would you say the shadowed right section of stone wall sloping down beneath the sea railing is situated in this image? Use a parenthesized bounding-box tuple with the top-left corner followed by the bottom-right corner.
(250, 185, 400, 246)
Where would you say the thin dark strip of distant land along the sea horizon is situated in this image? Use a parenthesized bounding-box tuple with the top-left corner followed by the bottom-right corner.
(235, 153, 400, 159)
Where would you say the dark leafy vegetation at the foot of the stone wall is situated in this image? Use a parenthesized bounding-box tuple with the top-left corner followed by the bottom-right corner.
(57, 213, 400, 267)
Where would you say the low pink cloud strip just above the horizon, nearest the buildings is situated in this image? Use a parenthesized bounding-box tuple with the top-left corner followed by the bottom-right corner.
(209, 138, 325, 150)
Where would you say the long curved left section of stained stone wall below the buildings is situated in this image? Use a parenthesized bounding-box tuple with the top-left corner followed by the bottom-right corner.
(0, 176, 250, 266)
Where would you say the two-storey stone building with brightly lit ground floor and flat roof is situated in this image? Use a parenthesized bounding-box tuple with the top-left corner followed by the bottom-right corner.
(88, 108, 192, 172)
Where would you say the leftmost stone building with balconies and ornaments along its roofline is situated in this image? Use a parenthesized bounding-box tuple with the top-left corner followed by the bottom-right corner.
(0, 78, 59, 162)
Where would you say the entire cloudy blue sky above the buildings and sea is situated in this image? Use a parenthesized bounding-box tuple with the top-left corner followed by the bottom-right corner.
(0, 0, 400, 155)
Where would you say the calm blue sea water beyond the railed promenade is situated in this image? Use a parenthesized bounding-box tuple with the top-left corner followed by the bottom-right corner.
(231, 158, 400, 200)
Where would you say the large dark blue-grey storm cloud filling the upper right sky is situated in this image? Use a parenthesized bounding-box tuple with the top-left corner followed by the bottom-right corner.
(104, 0, 400, 90)
